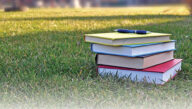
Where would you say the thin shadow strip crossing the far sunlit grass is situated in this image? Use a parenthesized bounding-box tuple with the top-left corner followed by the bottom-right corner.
(0, 15, 190, 21)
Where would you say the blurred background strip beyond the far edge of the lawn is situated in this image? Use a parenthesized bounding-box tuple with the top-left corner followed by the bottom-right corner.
(0, 0, 183, 8)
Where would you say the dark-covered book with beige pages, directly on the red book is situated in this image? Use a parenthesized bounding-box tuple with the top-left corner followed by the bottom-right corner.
(96, 51, 173, 69)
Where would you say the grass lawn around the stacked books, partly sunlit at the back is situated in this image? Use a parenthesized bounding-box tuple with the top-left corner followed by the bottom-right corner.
(0, 6, 192, 109)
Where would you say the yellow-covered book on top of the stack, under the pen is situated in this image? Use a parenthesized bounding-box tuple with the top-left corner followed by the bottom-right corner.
(84, 32, 171, 46)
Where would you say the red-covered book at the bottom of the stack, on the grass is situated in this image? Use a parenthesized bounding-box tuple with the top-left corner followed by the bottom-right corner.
(98, 59, 182, 85)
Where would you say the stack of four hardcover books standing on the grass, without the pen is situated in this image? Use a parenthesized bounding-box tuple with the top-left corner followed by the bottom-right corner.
(85, 32, 182, 84)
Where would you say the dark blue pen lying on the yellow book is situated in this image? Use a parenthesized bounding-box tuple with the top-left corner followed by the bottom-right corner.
(114, 29, 151, 34)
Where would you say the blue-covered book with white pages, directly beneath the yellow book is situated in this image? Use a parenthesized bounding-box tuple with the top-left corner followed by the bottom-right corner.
(91, 40, 175, 57)
